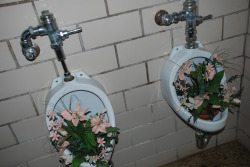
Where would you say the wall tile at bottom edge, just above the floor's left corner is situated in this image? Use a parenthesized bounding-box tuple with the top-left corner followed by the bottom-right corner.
(136, 149, 177, 167)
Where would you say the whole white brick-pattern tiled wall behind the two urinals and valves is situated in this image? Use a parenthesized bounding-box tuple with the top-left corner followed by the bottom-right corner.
(0, 0, 250, 167)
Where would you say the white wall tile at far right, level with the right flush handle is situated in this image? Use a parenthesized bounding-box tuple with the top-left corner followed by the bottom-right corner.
(223, 10, 249, 38)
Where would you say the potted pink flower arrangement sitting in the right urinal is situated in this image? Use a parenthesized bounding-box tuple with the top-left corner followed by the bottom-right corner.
(173, 48, 243, 122)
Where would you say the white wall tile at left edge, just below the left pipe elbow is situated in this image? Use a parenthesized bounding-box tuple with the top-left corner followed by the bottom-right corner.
(0, 62, 56, 99)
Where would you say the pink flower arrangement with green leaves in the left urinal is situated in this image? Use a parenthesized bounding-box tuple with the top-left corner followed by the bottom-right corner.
(47, 104, 119, 167)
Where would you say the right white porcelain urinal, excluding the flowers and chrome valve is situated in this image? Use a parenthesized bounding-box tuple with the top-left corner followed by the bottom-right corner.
(161, 42, 228, 132)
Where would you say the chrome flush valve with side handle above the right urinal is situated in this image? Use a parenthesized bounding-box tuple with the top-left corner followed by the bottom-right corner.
(155, 0, 212, 49)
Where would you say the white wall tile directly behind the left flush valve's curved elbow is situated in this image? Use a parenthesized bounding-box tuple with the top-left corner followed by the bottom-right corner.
(10, 26, 82, 66)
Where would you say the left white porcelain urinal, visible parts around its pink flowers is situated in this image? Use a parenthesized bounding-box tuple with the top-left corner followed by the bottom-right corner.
(46, 72, 116, 167)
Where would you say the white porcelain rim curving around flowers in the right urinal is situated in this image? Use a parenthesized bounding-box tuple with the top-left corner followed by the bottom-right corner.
(161, 42, 228, 132)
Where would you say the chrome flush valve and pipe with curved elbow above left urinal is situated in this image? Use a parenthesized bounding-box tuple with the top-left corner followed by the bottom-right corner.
(20, 10, 82, 82)
